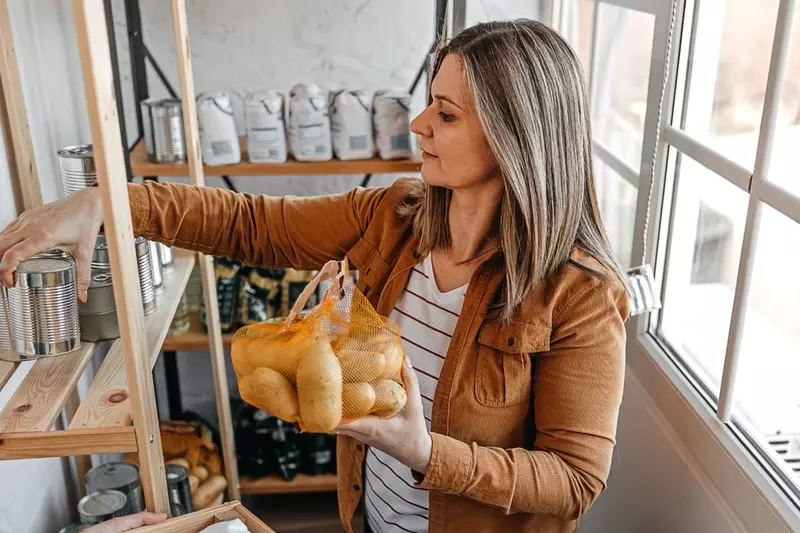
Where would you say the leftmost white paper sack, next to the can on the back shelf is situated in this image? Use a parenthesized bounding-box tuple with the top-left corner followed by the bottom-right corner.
(197, 92, 242, 166)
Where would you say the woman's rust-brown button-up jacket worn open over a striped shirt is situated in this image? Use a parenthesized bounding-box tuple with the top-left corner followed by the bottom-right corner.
(129, 179, 628, 533)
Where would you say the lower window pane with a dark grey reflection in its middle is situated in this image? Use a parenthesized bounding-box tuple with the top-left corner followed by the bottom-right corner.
(659, 156, 747, 395)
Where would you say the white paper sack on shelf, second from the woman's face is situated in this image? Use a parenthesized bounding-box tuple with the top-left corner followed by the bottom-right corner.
(330, 89, 375, 161)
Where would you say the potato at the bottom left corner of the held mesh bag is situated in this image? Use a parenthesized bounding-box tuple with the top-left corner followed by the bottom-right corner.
(239, 368, 298, 422)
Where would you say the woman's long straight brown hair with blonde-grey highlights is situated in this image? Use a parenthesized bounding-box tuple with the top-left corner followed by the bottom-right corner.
(401, 19, 622, 321)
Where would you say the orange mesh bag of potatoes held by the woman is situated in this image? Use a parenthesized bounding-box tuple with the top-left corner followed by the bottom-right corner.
(231, 260, 407, 433)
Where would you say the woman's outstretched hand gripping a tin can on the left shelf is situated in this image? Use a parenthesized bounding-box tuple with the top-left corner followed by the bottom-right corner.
(0, 187, 103, 302)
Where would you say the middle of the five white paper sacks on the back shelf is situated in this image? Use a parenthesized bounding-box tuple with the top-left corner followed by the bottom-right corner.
(287, 83, 333, 161)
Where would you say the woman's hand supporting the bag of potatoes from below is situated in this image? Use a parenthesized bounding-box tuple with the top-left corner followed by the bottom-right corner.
(336, 357, 433, 474)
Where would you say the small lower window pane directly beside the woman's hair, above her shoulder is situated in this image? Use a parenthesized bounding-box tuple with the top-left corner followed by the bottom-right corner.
(594, 157, 636, 268)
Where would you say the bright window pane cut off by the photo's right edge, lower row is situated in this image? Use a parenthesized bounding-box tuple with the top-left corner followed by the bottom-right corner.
(735, 205, 800, 485)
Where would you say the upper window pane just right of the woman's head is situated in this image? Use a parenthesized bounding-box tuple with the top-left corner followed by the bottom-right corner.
(592, 4, 654, 169)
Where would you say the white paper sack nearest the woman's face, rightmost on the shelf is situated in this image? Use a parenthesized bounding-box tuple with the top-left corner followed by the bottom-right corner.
(372, 90, 411, 159)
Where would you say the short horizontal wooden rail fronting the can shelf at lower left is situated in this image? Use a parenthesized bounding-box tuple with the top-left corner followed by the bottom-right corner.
(0, 426, 136, 461)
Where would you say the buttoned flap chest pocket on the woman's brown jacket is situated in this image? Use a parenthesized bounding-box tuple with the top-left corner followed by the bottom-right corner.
(475, 322, 550, 407)
